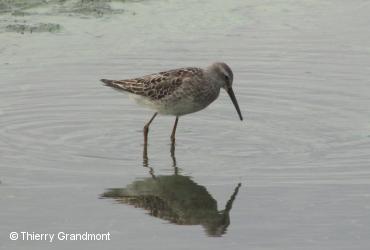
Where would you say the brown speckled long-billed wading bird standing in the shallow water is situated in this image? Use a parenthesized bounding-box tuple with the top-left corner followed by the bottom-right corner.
(101, 62, 243, 144)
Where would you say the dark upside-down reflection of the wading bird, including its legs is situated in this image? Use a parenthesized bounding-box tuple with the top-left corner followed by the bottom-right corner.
(102, 143, 241, 236)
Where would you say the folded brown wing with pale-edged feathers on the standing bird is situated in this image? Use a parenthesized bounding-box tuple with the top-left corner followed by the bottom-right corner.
(101, 68, 203, 100)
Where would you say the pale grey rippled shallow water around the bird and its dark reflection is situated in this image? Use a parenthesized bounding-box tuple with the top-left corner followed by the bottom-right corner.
(0, 0, 370, 249)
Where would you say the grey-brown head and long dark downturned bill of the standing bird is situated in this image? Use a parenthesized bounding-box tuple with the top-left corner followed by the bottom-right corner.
(208, 62, 243, 120)
